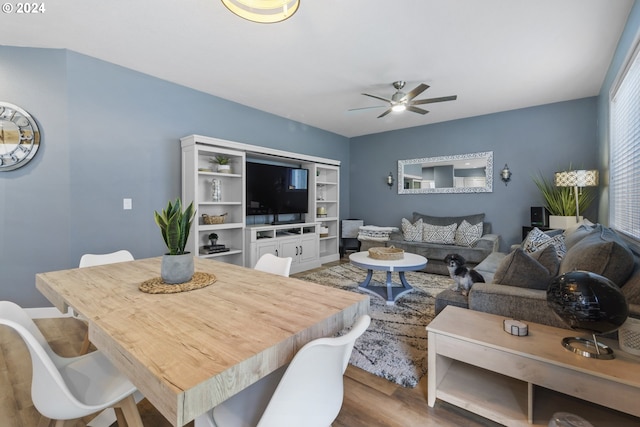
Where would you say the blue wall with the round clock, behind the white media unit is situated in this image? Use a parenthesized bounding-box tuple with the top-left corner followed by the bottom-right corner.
(0, 46, 349, 307)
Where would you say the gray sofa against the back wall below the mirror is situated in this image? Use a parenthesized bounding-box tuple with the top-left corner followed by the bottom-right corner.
(360, 212, 500, 276)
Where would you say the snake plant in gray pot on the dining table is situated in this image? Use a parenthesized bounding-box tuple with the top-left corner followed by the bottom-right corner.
(154, 198, 195, 284)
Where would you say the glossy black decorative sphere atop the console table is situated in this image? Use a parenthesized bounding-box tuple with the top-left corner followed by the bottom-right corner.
(547, 271, 629, 334)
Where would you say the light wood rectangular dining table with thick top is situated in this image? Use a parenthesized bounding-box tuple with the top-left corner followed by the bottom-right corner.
(36, 257, 369, 426)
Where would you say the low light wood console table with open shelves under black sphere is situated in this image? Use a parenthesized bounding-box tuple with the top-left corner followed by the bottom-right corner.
(427, 306, 640, 427)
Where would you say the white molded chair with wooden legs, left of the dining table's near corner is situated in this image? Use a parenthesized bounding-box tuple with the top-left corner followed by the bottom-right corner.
(0, 301, 142, 427)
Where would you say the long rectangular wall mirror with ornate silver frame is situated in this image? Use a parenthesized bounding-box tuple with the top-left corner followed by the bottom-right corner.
(398, 151, 493, 194)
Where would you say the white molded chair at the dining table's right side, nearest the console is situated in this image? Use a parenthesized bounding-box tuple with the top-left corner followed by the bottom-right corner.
(195, 315, 371, 427)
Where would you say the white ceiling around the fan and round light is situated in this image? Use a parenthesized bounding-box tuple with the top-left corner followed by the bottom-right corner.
(0, 0, 633, 137)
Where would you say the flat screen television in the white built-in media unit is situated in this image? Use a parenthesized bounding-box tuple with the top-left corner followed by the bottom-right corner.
(246, 162, 309, 222)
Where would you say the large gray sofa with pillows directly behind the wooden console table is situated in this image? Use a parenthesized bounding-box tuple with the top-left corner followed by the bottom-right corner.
(436, 224, 640, 328)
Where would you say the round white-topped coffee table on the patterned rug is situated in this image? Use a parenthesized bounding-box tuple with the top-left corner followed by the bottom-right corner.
(349, 252, 427, 305)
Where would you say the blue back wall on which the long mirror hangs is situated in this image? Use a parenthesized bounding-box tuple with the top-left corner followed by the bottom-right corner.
(350, 97, 598, 251)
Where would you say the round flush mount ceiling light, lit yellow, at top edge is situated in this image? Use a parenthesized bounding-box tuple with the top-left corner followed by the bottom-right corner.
(222, 0, 300, 24)
